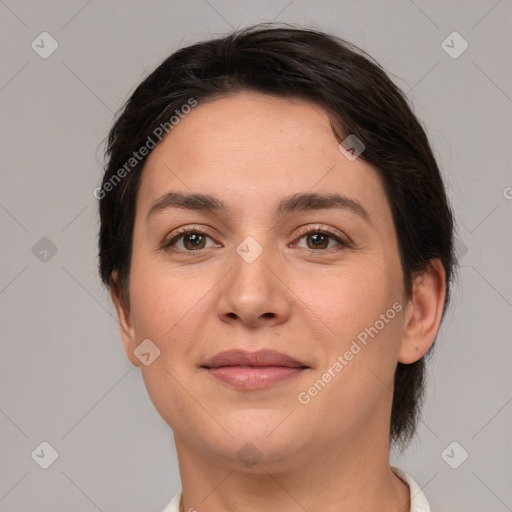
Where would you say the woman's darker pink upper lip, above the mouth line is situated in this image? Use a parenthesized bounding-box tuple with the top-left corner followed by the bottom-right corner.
(202, 350, 308, 368)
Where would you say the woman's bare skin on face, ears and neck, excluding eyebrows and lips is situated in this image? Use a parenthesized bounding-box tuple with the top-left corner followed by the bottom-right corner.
(111, 92, 445, 512)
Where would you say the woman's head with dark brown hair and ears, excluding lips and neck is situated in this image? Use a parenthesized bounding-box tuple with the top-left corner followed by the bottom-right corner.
(97, 26, 454, 458)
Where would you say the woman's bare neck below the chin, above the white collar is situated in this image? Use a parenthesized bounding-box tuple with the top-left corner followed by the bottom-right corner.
(175, 422, 410, 512)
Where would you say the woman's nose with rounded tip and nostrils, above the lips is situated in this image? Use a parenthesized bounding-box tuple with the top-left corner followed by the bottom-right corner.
(217, 240, 293, 328)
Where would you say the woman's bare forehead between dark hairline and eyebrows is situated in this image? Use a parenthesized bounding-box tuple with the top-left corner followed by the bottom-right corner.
(137, 92, 389, 228)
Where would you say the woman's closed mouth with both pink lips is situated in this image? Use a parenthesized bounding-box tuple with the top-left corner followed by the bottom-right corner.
(202, 350, 309, 390)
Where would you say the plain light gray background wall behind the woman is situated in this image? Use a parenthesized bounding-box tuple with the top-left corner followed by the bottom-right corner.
(0, 0, 512, 512)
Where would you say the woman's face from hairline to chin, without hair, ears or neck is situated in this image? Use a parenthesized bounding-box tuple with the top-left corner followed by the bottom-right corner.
(113, 92, 407, 464)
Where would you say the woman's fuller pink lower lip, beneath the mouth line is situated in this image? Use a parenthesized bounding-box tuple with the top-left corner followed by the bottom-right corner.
(207, 366, 305, 389)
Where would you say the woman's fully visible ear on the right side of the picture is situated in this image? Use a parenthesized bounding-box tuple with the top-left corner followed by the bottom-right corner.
(398, 259, 446, 364)
